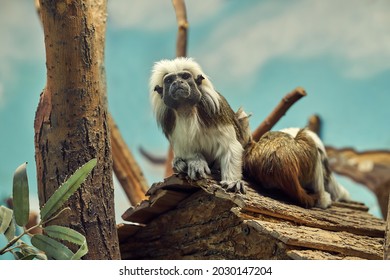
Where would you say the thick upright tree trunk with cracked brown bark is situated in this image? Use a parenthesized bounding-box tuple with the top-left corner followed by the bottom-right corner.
(34, 0, 120, 259)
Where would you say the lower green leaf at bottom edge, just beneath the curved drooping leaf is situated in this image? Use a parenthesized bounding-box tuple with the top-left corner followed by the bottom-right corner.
(31, 234, 74, 260)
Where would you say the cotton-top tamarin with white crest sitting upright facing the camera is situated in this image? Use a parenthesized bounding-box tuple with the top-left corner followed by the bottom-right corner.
(150, 57, 248, 192)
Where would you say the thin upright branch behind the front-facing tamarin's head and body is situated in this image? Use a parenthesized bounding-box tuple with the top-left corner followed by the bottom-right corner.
(165, 0, 189, 177)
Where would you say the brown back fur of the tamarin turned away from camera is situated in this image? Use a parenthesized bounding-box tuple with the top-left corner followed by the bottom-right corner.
(243, 130, 318, 207)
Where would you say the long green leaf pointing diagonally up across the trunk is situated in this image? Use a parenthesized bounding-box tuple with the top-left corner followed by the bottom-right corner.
(41, 158, 97, 221)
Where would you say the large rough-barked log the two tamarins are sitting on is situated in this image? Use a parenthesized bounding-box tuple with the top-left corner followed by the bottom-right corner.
(118, 176, 385, 260)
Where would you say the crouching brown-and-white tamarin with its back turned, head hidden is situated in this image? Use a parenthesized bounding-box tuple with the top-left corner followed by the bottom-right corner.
(243, 128, 349, 208)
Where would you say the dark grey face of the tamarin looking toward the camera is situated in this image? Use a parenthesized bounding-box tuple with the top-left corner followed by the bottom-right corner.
(155, 71, 202, 110)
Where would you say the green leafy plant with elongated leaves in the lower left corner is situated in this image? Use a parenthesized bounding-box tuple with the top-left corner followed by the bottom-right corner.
(0, 159, 97, 260)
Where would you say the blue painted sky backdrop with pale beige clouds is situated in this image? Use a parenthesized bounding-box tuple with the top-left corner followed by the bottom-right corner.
(0, 0, 390, 260)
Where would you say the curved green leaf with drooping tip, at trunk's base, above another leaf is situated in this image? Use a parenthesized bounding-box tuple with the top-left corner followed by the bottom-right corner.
(45, 226, 88, 260)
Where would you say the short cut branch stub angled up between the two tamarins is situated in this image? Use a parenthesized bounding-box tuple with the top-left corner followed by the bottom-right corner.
(252, 87, 306, 142)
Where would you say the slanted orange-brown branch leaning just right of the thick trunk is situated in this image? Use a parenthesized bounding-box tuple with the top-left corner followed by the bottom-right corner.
(108, 115, 149, 205)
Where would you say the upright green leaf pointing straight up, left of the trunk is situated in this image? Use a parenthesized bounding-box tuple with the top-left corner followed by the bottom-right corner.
(13, 162, 30, 227)
